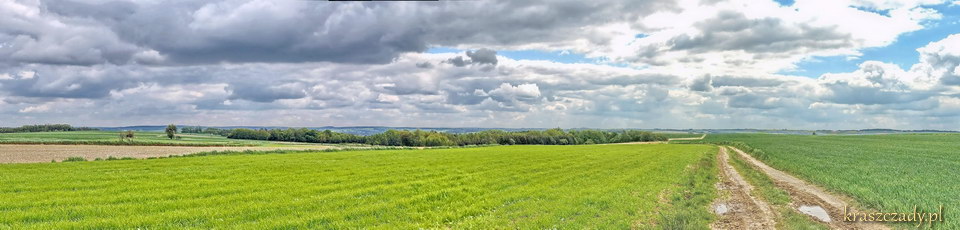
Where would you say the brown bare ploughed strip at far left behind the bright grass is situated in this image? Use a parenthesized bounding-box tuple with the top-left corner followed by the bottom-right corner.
(0, 145, 335, 163)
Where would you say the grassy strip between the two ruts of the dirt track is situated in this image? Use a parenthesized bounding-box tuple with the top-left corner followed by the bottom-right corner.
(730, 147, 830, 230)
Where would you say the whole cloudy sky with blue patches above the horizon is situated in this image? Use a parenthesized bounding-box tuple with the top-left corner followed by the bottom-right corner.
(0, 0, 960, 130)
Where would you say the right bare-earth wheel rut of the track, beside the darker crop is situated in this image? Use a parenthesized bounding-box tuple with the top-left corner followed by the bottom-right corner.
(730, 147, 890, 229)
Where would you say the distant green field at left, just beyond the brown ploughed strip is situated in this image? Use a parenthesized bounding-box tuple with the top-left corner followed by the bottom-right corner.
(0, 131, 326, 146)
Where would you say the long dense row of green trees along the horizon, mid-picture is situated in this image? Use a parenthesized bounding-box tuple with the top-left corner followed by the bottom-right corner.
(220, 128, 667, 146)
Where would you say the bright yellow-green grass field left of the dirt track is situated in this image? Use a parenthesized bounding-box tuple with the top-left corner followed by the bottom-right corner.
(0, 145, 716, 229)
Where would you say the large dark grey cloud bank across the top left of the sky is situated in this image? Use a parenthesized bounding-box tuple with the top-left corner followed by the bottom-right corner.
(0, 0, 673, 65)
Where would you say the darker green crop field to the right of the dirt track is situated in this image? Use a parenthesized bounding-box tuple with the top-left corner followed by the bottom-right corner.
(688, 134, 960, 229)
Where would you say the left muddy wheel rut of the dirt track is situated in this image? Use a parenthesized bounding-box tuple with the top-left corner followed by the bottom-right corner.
(710, 147, 776, 229)
